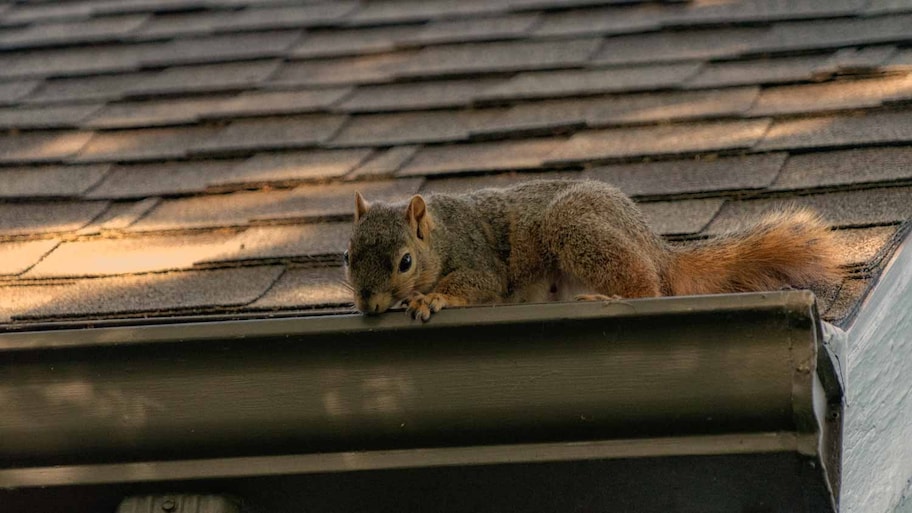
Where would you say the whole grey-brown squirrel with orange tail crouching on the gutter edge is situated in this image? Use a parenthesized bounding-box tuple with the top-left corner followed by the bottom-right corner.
(343, 180, 841, 321)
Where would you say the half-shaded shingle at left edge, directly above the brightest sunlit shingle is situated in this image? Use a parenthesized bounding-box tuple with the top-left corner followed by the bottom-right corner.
(0, 201, 108, 235)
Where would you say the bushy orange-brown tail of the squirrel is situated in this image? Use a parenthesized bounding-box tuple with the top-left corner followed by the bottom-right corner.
(667, 208, 842, 295)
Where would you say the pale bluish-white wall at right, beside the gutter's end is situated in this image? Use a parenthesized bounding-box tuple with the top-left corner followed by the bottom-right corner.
(840, 233, 912, 513)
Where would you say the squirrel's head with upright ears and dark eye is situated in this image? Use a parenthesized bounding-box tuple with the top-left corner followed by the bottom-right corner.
(344, 193, 440, 314)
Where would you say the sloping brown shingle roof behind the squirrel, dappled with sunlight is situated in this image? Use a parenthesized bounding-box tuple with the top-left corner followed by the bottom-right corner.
(0, 0, 912, 329)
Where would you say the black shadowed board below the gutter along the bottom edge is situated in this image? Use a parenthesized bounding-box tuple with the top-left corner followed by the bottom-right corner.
(0, 452, 829, 513)
